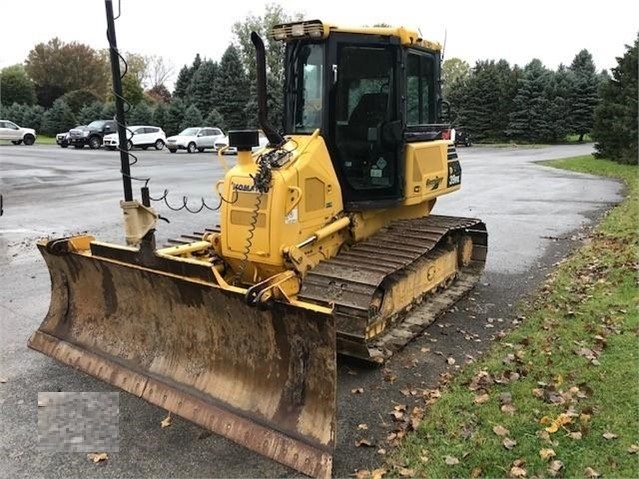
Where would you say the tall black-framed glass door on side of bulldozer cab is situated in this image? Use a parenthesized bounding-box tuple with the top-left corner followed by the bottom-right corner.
(329, 34, 403, 210)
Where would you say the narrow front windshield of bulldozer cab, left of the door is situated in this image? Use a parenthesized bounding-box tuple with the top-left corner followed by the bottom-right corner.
(288, 43, 324, 133)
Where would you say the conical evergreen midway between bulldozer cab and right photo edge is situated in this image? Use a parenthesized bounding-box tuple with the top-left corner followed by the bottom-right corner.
(507, 59, 552, 142)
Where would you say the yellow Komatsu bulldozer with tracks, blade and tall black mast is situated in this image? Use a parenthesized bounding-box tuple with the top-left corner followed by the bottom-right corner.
(28, 8, 487, 477)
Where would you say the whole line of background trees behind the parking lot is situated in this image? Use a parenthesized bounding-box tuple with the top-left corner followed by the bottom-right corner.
(0, 4, 637, 162)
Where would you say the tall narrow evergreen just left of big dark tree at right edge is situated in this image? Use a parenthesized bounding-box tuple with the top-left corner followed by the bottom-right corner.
(570, 50, 599, 141)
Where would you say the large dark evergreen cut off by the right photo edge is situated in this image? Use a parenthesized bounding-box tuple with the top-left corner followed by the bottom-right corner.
(593, 38, 639, 164)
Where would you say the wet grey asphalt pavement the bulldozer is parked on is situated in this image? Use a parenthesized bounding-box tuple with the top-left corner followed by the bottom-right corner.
(0, 144, 622, 478)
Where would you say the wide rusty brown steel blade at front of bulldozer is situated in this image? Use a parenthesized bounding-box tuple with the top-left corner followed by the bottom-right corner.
(29, 239, 336, 477)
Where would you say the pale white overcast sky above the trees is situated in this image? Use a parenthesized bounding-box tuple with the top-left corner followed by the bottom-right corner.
(0, 0, 639, 86)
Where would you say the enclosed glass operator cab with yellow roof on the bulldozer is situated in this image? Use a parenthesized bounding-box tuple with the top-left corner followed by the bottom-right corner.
(273, 21, 442, 210)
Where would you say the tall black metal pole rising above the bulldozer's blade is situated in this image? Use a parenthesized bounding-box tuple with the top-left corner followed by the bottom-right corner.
(105, 0, 133, 201)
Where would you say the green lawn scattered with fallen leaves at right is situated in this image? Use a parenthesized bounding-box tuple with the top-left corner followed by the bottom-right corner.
(387, 156, 639, 477)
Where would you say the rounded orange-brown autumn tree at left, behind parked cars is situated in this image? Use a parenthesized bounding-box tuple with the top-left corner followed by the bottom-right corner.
(25, 38, 109, 107)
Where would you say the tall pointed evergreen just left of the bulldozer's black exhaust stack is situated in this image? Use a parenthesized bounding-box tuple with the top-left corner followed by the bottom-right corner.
(213, 45, 248, 129)
